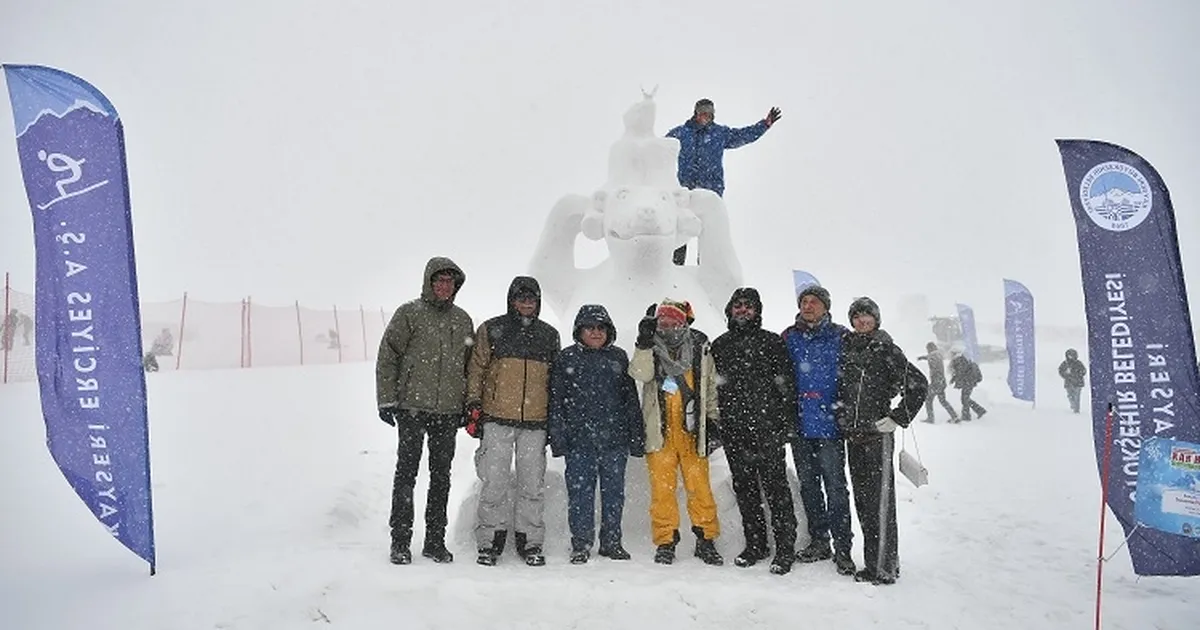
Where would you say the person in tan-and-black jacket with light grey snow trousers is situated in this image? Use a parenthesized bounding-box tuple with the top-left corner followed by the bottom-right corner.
(467, 276, 559, 566)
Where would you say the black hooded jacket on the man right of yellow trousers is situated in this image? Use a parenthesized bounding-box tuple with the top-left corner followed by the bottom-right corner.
(712, 287, 797, 451)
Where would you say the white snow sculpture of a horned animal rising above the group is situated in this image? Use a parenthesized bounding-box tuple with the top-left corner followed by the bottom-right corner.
(529, 92, 742, 340)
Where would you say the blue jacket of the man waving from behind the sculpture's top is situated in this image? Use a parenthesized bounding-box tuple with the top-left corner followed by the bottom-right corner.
(667, 119, 767, 196)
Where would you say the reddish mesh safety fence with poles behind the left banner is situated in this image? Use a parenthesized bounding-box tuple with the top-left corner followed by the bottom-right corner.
(0, 274, 390, 384)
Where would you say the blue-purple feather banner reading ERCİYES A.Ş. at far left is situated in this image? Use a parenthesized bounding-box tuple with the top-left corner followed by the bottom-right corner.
(4, 65, 155, 574)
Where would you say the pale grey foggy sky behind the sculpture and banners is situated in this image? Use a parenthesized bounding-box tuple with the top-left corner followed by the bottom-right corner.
(0, 0, 1200, 338)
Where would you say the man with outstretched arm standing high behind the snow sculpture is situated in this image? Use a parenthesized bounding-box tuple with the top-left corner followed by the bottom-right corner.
(667, 98, 782, 265)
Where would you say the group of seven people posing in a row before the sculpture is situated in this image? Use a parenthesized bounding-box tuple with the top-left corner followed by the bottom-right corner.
(376, 258, 928, 584)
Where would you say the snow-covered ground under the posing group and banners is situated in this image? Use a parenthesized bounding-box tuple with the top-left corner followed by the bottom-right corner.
(0, 354, 1200, 630)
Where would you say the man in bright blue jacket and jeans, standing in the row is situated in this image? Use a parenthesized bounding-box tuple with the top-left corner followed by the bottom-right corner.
(784, 284, 857, 576)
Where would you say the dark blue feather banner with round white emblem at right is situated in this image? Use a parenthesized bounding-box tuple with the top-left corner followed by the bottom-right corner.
(1057, 140, 1200, 575)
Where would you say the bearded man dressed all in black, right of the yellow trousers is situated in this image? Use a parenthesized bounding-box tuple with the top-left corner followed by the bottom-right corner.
(713, 287, 796, 575)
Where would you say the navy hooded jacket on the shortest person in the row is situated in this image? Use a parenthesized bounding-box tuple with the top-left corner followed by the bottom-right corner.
(547, 305, 646, 457)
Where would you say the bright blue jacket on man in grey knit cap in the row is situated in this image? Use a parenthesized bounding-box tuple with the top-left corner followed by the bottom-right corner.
(784, 314, 846, 439)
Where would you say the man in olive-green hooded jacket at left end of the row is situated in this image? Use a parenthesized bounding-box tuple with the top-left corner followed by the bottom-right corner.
(376, 257, 475, 564)
